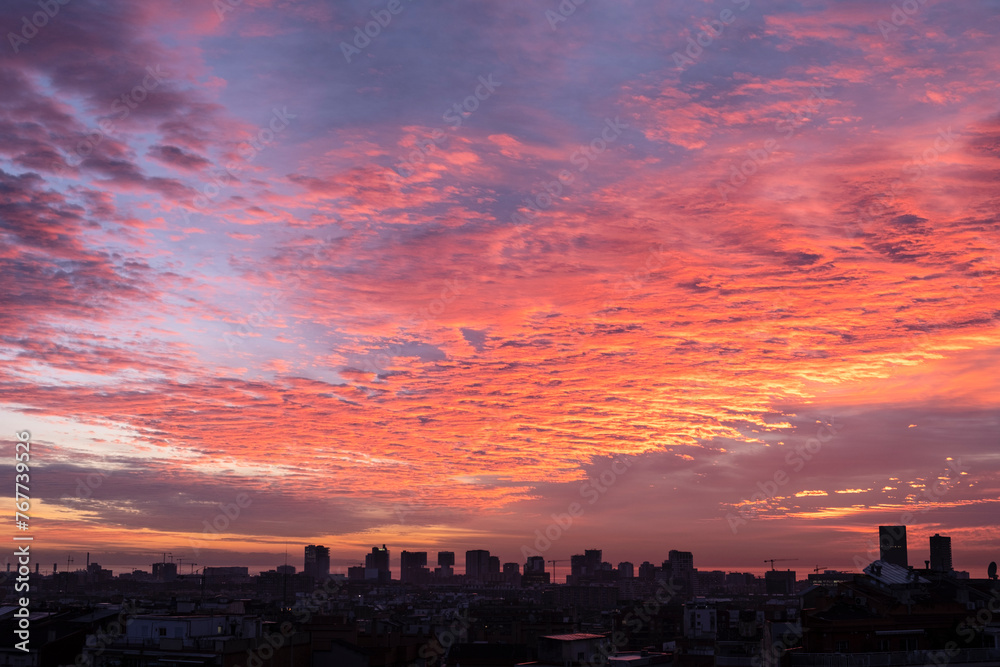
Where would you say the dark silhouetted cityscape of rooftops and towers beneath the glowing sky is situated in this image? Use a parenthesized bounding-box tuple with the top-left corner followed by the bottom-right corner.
(0, 535, 1000, 667)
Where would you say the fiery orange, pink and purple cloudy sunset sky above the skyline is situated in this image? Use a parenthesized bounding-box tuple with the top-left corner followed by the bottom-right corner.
(0, 0, 1000, 579)
